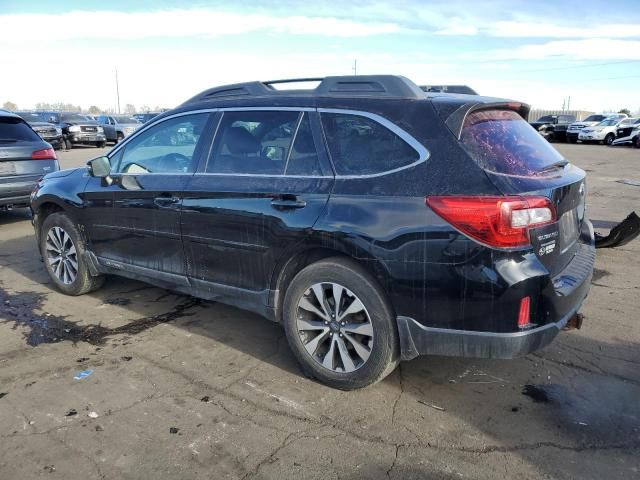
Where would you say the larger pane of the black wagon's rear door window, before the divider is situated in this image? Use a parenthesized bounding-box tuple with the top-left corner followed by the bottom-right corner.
(207, 111, 301, 175)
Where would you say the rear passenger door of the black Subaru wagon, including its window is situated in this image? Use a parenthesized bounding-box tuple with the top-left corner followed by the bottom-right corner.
(182, 109, 333, 295)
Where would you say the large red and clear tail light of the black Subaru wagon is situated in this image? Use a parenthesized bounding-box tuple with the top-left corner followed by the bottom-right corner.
(426, 196, 557, 248)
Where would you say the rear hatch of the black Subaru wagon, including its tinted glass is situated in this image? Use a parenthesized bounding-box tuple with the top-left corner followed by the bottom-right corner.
(460, 108, 586, 275)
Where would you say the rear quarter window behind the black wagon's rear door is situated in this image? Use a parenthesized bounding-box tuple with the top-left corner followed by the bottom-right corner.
(322, 113, 420, 175)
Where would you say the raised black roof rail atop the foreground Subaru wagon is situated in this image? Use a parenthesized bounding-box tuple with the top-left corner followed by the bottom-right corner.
(184, 75, 424, 104)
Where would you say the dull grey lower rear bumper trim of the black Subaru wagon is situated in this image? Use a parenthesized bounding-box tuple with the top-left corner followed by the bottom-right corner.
(397, 304, 582, 360)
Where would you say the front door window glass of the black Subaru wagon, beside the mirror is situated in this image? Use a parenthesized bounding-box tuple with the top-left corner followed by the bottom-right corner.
(116, 114, 208, 174)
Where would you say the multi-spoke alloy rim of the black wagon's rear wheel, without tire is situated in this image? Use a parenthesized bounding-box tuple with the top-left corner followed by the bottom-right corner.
(296, 282, 373, 373)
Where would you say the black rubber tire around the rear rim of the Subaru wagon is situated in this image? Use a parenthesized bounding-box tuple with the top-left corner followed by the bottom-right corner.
(282, 257, 400, 390)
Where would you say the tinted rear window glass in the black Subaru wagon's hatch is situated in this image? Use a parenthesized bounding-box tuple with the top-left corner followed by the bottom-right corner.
(460, 110, 566, 177)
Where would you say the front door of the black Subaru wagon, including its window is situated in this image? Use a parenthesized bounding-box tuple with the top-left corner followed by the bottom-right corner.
(84, 114, 210, 283)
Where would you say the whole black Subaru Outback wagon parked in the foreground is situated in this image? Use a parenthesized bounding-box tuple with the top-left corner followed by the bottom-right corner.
(31, 76, 595, 389)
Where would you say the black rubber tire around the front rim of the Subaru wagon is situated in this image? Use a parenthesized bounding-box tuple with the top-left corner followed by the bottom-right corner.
(40, 212, 104, 296)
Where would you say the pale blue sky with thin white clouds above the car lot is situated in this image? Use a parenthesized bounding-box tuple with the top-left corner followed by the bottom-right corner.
(0, 0, 640, 112)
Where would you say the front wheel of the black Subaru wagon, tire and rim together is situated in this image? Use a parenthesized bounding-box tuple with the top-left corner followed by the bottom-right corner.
(40, 212, 104, 295)
